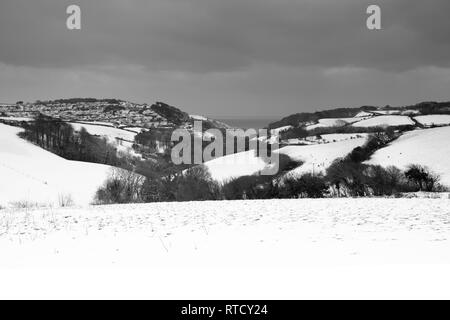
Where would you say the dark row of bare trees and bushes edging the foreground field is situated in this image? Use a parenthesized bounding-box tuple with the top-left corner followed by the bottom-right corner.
(96, 160, 443, 204)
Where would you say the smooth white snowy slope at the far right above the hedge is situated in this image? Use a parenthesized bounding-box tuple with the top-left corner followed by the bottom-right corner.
(368, 127, 450, 186)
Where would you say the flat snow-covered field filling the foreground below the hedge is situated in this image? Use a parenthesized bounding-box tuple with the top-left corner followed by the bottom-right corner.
(0, 198, 450, 299)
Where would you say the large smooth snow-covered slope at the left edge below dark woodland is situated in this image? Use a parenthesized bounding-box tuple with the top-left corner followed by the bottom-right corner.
(0, 124, 110, 206)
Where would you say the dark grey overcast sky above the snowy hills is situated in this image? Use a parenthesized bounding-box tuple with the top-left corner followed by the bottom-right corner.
(0, 0, 450, 118)
